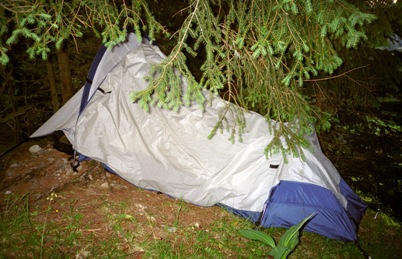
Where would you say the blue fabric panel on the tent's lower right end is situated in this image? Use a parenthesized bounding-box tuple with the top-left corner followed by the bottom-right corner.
(261, 181, 362, 240)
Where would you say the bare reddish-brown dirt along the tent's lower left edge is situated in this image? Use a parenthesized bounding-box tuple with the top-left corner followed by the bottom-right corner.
(0, 141, 231, 253)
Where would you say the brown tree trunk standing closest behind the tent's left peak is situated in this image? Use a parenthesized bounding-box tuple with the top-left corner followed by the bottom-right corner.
(57, 45, 74, 103)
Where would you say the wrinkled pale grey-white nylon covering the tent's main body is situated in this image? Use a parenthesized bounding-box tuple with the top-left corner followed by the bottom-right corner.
(73, 44, 347, 212)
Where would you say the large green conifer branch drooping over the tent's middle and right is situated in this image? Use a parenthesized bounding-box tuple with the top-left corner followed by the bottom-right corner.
(134, 0, 375, 156)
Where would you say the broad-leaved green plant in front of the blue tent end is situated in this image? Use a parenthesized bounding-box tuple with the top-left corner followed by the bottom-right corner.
(239, 213, 316, 259)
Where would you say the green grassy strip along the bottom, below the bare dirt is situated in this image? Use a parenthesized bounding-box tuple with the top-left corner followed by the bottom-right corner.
(0, 195, 402, 259)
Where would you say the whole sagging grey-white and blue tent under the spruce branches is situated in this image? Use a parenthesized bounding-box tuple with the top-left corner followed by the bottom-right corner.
(31, 33, 366, 241)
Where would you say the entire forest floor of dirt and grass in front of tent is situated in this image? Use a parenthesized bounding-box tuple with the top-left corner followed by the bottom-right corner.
(0, 140, 402, 258)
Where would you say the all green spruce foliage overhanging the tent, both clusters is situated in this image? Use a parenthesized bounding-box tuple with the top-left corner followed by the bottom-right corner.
(0, 0, 396, 156)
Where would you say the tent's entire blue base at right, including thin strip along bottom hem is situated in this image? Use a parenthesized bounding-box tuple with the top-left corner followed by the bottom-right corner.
(221, 180, 367, 241)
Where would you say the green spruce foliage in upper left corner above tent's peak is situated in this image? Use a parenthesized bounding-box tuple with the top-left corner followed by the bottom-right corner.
(0, 0, 163, 65)
